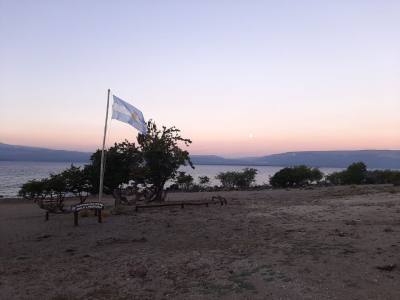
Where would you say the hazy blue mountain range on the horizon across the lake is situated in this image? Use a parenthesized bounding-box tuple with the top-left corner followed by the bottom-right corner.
(0, 143, 400, 169)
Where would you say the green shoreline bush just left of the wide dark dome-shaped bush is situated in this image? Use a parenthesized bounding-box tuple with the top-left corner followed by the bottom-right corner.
(215, 168, 257, 189)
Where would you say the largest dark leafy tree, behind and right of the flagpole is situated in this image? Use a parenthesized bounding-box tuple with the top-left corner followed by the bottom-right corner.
(86, 121, 193, 201)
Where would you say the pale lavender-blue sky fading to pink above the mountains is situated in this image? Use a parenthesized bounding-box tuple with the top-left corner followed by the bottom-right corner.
(0, 0, 400, 157)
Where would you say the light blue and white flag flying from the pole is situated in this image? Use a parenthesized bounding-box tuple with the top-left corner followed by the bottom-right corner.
(111, 95, 147, 134)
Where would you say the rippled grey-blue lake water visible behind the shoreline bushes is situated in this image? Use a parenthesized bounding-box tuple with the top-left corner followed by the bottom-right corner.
(0, 161, 341, 197)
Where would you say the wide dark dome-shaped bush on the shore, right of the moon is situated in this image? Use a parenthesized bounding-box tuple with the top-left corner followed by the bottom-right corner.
(270, 166, 323, 188)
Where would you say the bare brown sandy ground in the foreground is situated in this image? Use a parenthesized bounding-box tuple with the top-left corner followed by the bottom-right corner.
(0, 186, 400, 300)
